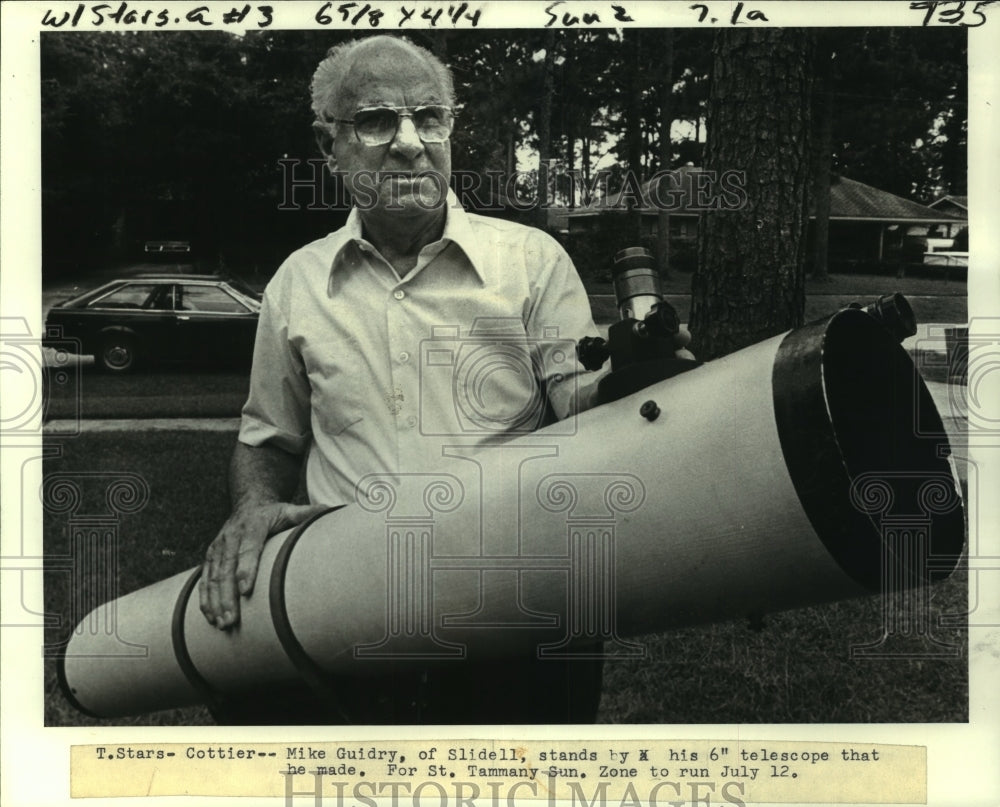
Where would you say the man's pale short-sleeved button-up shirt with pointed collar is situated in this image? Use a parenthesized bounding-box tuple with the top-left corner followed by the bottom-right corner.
(239, 195, 598, 505)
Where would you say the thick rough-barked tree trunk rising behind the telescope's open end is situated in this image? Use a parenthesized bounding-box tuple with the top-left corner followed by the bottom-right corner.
(691, 28, 812, 359)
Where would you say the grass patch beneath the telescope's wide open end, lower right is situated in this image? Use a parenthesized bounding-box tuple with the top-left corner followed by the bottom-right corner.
(600, 574, 968, 723)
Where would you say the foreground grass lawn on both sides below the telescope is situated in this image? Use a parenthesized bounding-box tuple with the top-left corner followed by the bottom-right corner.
(44, 432, 968, 726)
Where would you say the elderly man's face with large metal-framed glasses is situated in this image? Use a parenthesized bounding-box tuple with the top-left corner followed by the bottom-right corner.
(328, 43, 451, 217)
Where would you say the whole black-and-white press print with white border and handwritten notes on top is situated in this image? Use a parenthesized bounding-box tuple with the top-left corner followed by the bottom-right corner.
(2, 2, 1000, 807)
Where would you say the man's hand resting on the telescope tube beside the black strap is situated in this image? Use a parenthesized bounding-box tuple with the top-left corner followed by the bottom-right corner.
(198, 502, 328, 630)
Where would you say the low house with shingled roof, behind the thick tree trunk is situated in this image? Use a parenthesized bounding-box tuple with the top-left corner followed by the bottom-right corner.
(568, 165, 968, 271)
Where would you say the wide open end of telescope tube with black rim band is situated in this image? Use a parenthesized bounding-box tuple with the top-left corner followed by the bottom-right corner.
(771, 309, 965, 592)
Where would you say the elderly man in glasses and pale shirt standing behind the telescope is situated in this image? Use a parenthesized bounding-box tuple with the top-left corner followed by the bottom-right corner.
(200, 36, 612, 723)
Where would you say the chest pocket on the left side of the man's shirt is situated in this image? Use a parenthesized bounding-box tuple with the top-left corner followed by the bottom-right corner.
(302, 339, 372, 437)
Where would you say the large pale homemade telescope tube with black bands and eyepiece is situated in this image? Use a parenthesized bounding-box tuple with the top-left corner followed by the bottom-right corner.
(58, 253, 965, 717)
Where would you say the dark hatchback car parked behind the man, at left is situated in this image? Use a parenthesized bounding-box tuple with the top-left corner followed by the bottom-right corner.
(45, 274, 260, 373)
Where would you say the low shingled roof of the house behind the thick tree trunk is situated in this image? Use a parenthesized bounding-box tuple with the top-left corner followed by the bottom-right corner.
(569, 166, 965, 224)
